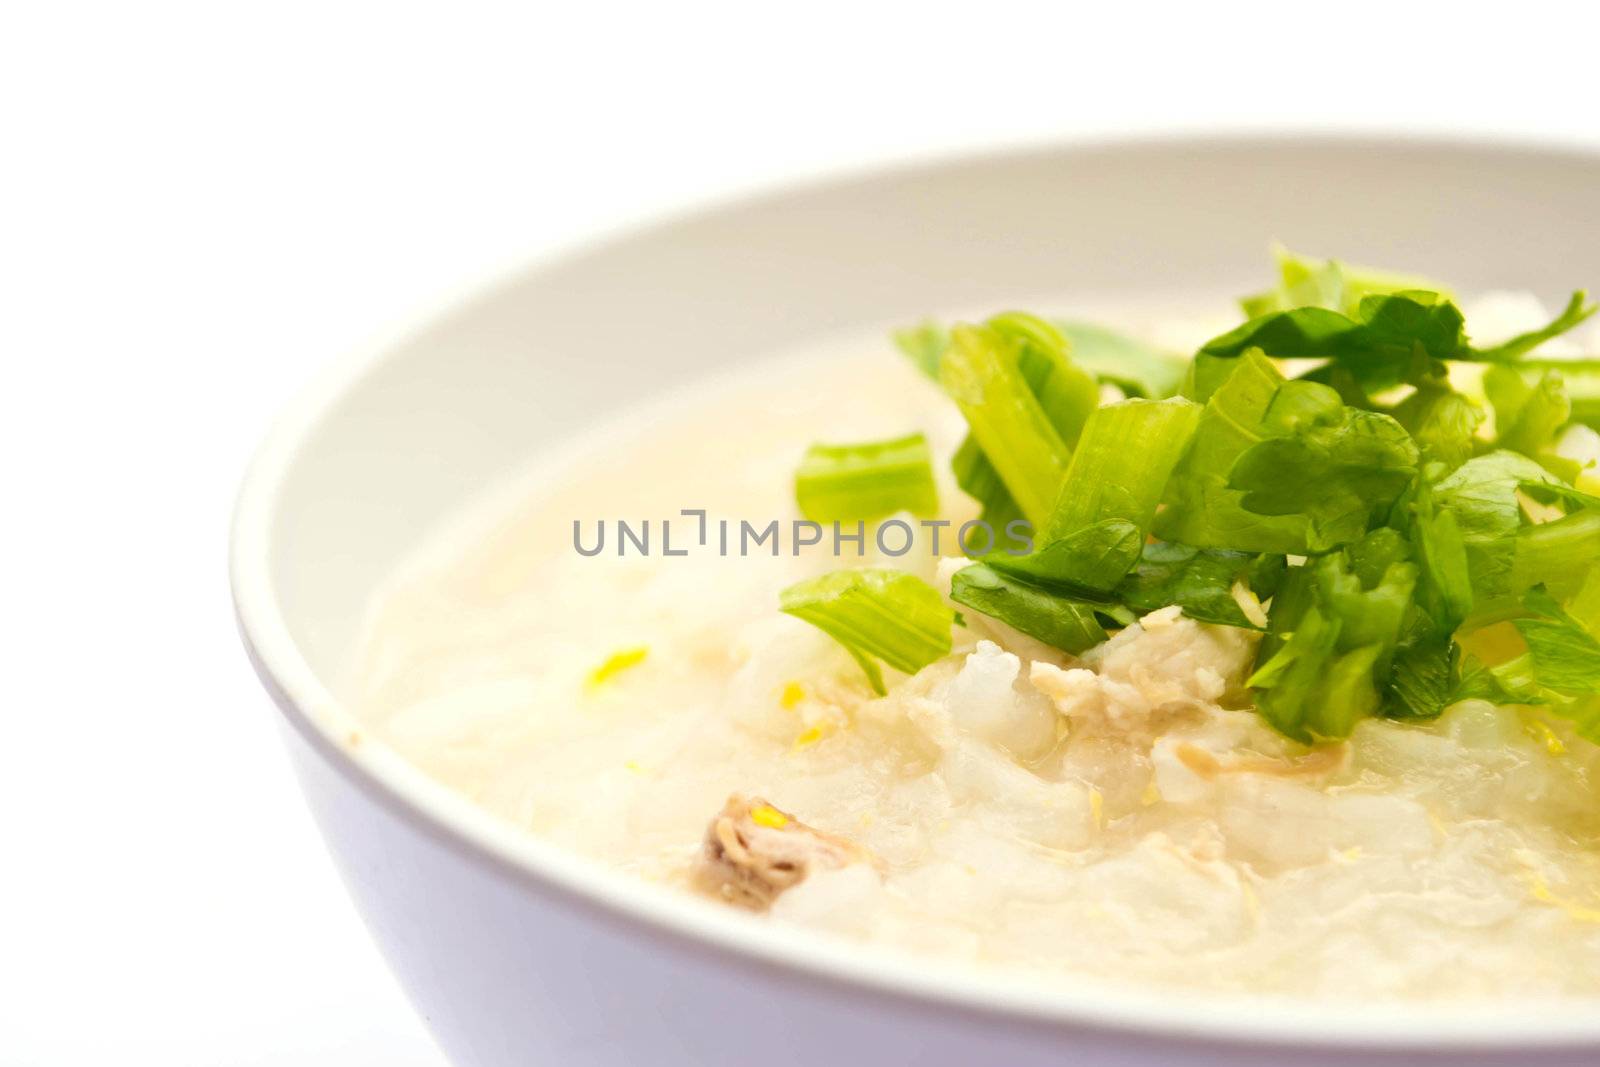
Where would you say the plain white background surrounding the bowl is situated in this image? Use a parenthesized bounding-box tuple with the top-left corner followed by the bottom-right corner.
(0, 0, 1600, 1067)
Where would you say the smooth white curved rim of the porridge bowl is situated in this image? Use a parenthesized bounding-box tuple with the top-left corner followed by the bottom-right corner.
(229, 131, 1600, 1051)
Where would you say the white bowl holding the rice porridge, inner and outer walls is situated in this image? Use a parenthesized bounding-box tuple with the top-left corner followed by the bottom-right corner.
(232, 139, 1600, 1067)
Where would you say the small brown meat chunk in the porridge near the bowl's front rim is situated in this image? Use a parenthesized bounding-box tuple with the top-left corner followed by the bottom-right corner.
(694, 793, 867, 912)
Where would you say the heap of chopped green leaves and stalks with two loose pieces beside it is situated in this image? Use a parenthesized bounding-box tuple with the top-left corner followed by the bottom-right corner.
(832, 250, 1600, 742)
